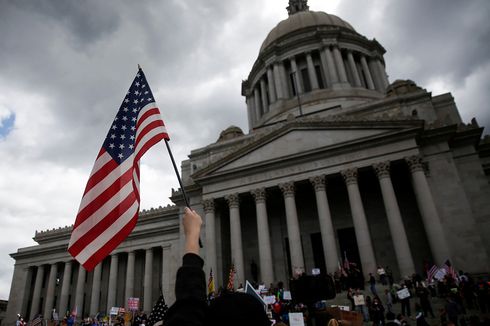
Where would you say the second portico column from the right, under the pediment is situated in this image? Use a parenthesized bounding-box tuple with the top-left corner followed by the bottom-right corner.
(373, 161, 415, 277)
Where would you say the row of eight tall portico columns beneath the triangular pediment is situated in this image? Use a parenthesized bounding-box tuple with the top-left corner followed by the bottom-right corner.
(203, 156, 450, 284)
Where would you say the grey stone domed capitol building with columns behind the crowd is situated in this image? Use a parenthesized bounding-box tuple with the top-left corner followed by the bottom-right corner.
(4, 0, 490, 325)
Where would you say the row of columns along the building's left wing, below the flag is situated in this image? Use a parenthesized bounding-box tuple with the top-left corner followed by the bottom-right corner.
(30, 247, 169, 319)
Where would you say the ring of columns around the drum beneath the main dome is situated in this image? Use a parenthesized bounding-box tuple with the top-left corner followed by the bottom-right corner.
(247, 46, 388, 122)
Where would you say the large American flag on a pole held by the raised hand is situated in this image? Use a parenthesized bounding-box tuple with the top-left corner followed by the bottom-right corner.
(68, 68, 169, 271)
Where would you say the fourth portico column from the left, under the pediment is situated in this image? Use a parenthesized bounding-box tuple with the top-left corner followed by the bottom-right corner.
(279, 182, 305, 275)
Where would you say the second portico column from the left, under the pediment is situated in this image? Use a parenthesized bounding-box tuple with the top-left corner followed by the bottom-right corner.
(225, 194, 245, 286)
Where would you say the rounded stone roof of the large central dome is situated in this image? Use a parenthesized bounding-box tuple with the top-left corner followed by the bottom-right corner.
(260, 11, 355, 52)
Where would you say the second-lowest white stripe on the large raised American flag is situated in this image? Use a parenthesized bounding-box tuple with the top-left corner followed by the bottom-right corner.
(69, 180, 133, 246)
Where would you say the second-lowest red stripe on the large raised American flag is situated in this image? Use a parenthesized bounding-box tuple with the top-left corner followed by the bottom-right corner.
(69, 193, 136, 256)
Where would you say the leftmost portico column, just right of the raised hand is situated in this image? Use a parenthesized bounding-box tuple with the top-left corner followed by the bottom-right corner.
(202, 199, 218, 285)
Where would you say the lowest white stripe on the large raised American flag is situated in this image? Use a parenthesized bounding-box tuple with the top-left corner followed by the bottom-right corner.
(75, 201, 139, 264)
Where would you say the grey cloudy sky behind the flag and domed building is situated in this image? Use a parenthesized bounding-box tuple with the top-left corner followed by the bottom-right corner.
(0, 0, 490, 299)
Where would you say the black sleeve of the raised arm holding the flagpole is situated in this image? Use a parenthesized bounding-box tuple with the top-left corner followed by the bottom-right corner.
(164, 254, 207, 326)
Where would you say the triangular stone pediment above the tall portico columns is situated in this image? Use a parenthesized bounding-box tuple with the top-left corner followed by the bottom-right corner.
(194, 121, 420, 178)
